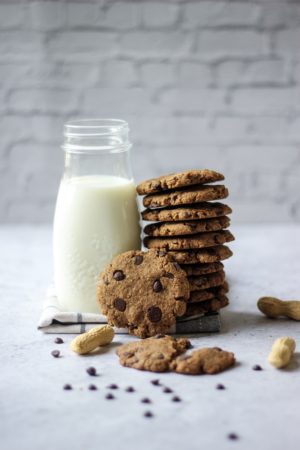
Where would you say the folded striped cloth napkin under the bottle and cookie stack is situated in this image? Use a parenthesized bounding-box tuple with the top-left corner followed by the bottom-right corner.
(38, 286, 220, 334)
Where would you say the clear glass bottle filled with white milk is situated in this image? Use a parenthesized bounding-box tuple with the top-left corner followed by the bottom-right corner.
(53, 119, 141, 313)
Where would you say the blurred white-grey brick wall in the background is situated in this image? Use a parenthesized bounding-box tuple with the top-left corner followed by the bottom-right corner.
(0, 0, 300, 222)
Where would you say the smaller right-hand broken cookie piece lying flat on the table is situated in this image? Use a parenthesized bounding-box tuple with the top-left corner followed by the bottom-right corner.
(171, 347, 235, 375)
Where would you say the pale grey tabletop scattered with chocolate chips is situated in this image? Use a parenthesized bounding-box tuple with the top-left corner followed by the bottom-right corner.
(0, 225, 300, 450)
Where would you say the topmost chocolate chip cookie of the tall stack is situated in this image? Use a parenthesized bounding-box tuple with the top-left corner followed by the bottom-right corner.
(136, 169, 224, 195)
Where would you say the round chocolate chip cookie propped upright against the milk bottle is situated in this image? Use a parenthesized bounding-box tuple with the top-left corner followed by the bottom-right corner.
(97, 250, 189, 338)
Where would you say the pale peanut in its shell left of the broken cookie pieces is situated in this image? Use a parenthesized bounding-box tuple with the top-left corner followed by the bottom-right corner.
(70, 325, 115, 355)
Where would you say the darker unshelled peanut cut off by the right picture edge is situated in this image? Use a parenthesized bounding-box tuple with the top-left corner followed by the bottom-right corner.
(257, 297, 300, 320)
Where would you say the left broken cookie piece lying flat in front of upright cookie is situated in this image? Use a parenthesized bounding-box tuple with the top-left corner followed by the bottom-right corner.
(117, 335, 191, 372)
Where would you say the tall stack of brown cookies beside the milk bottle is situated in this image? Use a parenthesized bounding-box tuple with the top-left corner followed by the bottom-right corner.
(137, 169, 234, 317)
